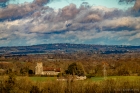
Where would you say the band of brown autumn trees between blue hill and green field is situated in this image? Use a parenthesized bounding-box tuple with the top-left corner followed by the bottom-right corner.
(0, 53, 140, 77)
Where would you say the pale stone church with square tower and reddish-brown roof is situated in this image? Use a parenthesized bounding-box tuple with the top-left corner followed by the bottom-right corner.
(35, 62, 61, 75)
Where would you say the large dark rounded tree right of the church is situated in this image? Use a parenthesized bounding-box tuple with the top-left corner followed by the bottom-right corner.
(65, 62, 85, 76)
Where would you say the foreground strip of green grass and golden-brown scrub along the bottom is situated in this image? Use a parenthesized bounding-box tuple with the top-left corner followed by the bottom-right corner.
(0, 76, 140, 93)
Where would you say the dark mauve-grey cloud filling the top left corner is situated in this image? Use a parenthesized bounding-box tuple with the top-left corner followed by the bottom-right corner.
(0, 0, 49, 21)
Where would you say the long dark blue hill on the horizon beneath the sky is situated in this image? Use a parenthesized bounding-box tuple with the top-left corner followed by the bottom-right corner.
(0, 43, 140, 55)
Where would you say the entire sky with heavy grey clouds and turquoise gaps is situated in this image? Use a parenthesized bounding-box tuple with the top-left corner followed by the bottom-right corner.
(0, 0, 140, 46)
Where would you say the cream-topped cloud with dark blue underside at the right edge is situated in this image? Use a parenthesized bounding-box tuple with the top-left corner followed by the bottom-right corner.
(98, 17, 140, 31)
